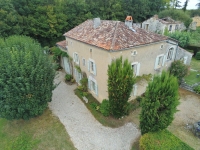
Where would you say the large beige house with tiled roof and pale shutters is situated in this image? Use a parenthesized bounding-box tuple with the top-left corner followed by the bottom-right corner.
(57, 16, 191, 102)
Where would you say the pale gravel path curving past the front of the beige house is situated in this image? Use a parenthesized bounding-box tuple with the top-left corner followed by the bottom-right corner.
(49, 72, 140, 150)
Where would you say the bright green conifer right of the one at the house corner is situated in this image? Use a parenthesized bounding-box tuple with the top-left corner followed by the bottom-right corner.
(140, 72, 179, 134)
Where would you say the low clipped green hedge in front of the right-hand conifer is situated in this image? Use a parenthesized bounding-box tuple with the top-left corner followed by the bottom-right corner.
(140, 130, 193, 150)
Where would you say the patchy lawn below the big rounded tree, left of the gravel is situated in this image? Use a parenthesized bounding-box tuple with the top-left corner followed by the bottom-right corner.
(0, 109, 75, 150)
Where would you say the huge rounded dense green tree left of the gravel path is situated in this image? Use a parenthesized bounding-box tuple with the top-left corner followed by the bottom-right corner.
(0, 36, 55, 119)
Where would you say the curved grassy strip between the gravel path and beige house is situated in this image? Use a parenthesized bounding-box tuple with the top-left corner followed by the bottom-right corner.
(74, 89, 139, 128)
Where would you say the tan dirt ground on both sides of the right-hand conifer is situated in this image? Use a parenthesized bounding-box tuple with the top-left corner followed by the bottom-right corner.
(126, 89, 200, 150)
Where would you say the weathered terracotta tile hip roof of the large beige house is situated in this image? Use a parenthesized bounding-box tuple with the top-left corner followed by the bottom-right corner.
(64, 20, 168, 50)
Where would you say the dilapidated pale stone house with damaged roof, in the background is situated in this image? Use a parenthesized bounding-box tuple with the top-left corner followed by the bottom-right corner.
(142, 15, 186, 35)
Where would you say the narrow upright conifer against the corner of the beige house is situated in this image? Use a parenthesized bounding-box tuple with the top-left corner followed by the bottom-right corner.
(108, 57, 134, 118)
